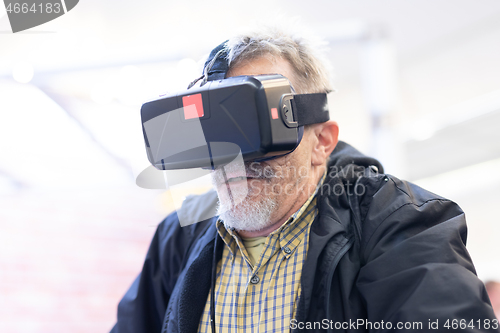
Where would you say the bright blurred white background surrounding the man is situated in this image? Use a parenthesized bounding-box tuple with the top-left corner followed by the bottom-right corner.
(0, 0, 500, 333)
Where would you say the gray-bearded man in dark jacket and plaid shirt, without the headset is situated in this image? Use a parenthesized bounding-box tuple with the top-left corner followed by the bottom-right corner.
(112, 29, 498, 333)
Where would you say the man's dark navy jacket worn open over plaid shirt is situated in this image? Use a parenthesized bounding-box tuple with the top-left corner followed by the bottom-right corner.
(112, 142, 500, 333)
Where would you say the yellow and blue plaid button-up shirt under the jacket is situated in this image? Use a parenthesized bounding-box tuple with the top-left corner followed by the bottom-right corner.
(198, 185, 318, 332)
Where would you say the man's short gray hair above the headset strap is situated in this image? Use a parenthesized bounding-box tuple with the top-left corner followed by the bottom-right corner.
(226, 27, 332, 94)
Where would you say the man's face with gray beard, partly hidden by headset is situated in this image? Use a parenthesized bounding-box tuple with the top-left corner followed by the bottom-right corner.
(212, 58, 312, 231)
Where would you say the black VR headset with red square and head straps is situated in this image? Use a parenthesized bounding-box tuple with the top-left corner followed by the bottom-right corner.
(141, 43, 330, 170)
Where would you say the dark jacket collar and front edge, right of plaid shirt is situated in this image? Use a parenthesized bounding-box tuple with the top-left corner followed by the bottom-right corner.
(296, 141, 383, 321)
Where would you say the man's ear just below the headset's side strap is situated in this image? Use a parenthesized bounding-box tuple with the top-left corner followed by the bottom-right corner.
(311, 120, 339, 166)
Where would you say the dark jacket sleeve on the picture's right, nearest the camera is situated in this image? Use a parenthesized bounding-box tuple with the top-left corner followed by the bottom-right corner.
(357, 177, 499, 332)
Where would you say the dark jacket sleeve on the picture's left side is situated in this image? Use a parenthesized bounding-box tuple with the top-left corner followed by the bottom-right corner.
(111, 191, 217, 333)
